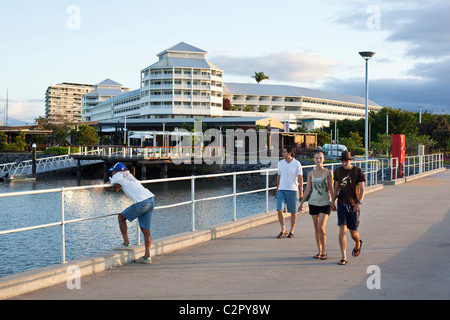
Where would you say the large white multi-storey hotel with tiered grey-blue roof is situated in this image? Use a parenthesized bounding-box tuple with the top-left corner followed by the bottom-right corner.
(83, 42, 381, 129)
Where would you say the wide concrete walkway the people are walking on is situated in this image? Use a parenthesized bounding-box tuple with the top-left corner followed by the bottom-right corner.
(8, 170, 450, 300)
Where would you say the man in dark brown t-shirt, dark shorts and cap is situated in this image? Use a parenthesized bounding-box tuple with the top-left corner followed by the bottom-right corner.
(331, 152, 365, 265)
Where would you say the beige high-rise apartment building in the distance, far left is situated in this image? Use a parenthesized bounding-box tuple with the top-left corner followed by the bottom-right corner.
(45, 82, 94, 123)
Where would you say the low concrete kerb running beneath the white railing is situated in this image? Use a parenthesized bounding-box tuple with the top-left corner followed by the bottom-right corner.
(0, 184, 383, 299)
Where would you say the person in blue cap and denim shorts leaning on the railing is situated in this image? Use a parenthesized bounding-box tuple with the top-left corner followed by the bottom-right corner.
(109, 162, 155, 263)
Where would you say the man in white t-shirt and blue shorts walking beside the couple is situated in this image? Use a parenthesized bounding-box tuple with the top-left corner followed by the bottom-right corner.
(277, 146, 303, 239)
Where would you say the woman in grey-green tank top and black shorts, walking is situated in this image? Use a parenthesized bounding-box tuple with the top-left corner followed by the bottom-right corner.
(298, 151, 333, 260)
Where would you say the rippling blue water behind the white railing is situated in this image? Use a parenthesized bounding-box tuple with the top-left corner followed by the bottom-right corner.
(0, 177, 276, 277)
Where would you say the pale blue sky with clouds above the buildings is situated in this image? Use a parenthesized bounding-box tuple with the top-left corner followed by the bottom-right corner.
(0, 0, 450, 123)
